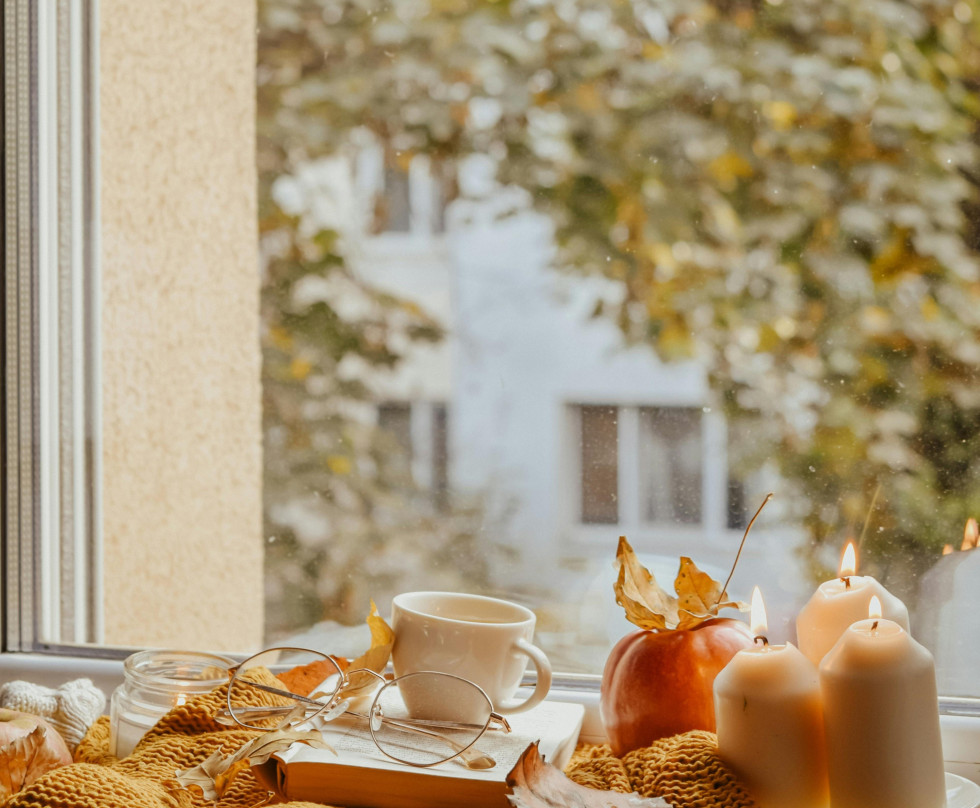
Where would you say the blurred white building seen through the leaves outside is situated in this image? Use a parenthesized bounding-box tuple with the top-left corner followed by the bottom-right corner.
(282, 148, 809, 644)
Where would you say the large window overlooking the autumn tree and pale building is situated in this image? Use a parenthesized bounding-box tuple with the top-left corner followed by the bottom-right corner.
(4, 0, 980, 724)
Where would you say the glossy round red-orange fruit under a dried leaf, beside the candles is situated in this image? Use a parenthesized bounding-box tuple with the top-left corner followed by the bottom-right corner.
(600, 617, 753, 757)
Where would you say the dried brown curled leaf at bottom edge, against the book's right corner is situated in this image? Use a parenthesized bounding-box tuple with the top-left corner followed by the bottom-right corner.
(507, 743, 670, 808)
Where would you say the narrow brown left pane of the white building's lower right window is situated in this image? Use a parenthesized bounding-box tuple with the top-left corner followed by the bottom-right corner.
(579, 407, 619, 524)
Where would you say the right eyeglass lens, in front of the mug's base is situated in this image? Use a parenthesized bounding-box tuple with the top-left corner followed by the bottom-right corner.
(370, 671, 493, 766)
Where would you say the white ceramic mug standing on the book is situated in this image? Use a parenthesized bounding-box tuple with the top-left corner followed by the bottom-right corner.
(391, 592, 551, 714)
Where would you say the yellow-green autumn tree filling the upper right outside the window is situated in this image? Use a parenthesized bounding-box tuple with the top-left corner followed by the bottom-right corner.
(259, 0, 980, 604)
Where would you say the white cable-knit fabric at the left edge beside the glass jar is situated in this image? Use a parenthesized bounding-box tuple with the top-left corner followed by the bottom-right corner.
(0, 679, 106, 752)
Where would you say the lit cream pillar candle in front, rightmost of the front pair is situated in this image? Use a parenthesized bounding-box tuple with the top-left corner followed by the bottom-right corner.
(820, 601, 946, 808)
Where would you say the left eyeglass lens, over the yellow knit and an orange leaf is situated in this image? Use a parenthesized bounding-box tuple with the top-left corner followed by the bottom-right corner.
(228, 648, 342, 730)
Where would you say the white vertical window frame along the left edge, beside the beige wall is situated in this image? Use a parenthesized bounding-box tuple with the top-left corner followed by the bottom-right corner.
(3, 0, 102, 651)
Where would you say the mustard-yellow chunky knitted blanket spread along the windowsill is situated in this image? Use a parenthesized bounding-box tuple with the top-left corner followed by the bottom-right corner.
(0, 688, 753, 808)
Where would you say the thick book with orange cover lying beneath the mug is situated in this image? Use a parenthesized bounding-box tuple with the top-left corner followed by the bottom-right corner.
(255, 701, 585, 808)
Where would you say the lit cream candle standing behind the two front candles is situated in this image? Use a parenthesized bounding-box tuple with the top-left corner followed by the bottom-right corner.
(796, 542, 909, 666)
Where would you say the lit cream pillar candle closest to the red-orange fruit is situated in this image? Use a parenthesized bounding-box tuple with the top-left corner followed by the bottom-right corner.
(714, 587, 827, 808)
